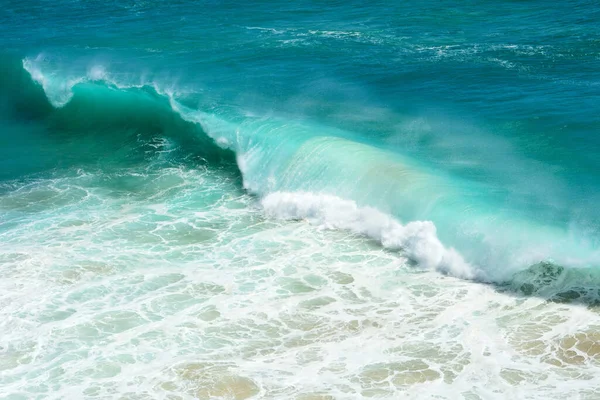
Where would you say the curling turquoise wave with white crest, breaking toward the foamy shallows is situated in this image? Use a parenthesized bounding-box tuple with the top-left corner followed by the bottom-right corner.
(0, 54, 600, 293)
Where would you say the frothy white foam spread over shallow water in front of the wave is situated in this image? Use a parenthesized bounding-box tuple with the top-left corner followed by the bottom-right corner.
(0, 164, 600, 400)
